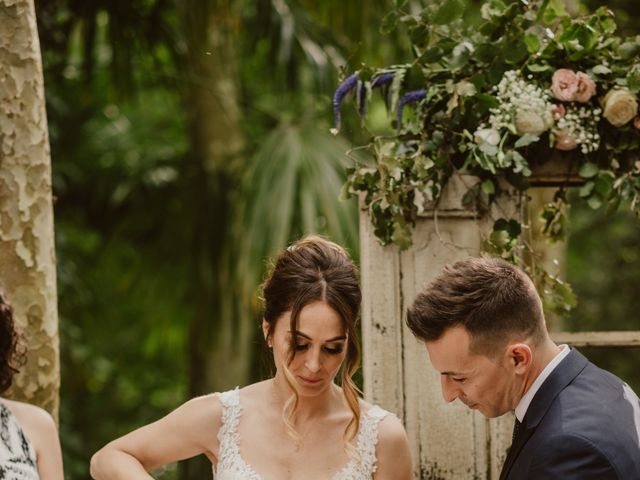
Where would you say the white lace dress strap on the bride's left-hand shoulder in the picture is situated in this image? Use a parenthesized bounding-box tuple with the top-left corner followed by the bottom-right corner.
(214, 387, 261, 480)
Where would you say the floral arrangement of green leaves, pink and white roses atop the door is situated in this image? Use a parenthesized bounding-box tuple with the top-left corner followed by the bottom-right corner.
(333, 0, 640, 311)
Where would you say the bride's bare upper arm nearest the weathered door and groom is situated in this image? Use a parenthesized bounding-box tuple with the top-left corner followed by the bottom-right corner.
(373, 415, 412, 480)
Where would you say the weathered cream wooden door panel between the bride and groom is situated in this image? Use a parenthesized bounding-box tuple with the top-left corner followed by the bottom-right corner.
(360, 177, 518, 480)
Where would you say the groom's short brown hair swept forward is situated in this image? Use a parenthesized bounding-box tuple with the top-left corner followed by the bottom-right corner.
(407, 258, 546, 357)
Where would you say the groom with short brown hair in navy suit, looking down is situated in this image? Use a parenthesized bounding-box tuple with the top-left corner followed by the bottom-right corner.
(407, 258, 640, 480)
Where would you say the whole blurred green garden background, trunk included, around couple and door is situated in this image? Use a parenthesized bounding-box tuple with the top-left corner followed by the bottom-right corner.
(36, 0, 640, 479)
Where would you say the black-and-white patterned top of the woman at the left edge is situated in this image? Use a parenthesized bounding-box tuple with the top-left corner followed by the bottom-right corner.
(0, 402, 40, 480)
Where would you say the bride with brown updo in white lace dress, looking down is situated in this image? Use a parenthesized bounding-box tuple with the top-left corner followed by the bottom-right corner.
(91, 237, 411, 480)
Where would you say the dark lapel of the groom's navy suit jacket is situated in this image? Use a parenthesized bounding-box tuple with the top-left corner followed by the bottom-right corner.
(500, 349, 589, 480)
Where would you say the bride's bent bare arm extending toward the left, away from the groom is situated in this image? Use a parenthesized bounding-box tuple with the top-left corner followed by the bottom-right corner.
(91, 395, 222, 480)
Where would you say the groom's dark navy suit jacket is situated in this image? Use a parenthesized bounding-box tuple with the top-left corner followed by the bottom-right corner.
(500, 350, 640, 480)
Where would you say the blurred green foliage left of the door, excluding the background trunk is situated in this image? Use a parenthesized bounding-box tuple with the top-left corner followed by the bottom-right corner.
(36, 0, 400, 479)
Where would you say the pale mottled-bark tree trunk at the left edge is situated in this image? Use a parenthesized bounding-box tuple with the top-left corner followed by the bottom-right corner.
(0, 0, 60, 417)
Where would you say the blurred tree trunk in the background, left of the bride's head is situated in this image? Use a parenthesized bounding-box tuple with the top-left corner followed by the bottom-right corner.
(183, 0, 253, 479)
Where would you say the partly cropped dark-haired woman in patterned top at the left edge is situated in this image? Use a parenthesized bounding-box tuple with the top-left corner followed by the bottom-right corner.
(0, 292, 64, 480)
